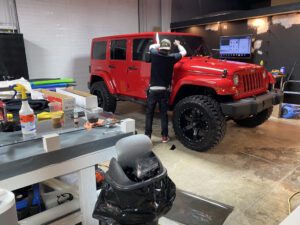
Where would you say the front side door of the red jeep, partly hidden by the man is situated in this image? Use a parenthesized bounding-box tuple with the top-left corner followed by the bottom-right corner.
(126, 36, 153, 99)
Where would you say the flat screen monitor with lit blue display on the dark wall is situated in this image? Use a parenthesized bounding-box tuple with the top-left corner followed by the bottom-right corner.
(220, 35, 252, 58)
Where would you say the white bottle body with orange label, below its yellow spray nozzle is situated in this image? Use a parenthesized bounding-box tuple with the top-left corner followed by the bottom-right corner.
(19, 99, 36, 135)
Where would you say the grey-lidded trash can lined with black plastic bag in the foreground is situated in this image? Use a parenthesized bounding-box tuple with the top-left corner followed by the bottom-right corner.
(93, 135, 176, 225)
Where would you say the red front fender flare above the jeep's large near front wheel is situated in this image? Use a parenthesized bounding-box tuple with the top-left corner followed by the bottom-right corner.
(170, 75, 236, 104)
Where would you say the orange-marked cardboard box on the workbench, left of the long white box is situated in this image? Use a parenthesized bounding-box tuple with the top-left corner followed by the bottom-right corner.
(40, 89, 75, 111)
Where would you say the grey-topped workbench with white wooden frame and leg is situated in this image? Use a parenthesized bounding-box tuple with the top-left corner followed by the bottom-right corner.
(0, 118, 134, 225)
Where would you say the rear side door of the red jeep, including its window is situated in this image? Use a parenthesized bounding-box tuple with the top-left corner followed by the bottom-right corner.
(108, 38, 128, 94)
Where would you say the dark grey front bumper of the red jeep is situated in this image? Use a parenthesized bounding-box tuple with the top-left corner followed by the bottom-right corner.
(221, 91, 283, 119)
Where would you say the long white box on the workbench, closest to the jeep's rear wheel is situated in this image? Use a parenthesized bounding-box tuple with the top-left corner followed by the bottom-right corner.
(56, 88, 98, 109)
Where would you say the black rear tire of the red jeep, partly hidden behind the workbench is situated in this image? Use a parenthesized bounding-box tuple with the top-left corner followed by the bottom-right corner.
(90, 81, 117, 113)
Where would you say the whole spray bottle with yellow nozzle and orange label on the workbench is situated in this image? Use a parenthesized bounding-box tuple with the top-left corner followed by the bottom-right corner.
(13, 84, 36, 135)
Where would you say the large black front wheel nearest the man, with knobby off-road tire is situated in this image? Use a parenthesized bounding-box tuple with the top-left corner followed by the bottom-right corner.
(173, 95, 226, 152)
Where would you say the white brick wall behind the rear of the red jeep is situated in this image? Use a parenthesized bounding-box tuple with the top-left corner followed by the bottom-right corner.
(16, 0, 138, 90)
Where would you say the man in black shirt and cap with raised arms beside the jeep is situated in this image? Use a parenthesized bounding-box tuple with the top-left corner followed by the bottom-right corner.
(145, 35, 186, 143)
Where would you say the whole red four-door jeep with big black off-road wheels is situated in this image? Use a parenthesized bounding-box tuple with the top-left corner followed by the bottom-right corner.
(89, 32, 283, 151)
